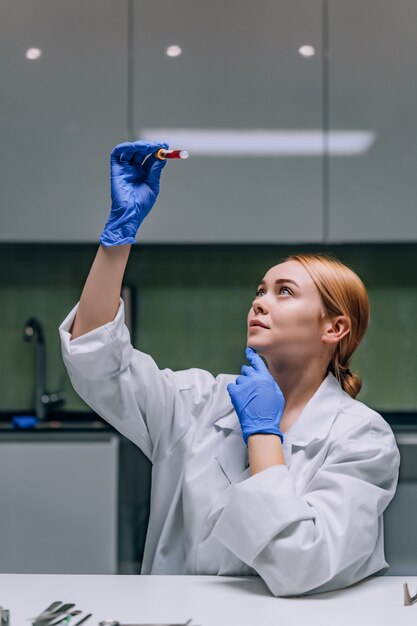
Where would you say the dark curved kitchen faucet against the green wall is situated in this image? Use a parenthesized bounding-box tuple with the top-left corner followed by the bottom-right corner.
(23, 317, 67, 420)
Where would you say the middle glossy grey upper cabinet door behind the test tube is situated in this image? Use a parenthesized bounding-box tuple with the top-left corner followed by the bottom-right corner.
(133, 0, 323, 242)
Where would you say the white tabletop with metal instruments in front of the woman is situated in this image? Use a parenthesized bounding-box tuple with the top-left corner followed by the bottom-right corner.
(0, 574, 417, 626)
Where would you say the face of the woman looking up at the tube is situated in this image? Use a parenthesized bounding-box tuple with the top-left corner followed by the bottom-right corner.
(247, 261, 329, 363)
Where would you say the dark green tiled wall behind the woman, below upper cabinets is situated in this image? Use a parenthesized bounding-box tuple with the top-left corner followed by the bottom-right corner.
(0, 243, 417, 411)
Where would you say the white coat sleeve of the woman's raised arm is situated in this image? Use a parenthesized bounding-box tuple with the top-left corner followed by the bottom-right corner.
(59, 299, 221, 463)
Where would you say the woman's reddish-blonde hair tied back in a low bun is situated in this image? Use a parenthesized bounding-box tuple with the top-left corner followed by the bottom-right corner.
(285, 254, 370, 398)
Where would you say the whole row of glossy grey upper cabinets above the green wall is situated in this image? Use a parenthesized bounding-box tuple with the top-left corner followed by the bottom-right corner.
(0, 0, 417, 243)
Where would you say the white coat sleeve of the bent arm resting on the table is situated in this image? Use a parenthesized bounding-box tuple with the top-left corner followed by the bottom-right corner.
(213, 420, 400, 596)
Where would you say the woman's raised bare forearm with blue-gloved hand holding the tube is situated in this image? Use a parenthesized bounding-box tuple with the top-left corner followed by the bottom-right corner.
(71, 141, 168, 339)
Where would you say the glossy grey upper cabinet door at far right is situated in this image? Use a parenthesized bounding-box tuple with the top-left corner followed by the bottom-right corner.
(328, 0, 417, 242)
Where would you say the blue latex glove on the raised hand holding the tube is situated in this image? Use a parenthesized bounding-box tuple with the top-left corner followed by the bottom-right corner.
(100, 141, 169, 246)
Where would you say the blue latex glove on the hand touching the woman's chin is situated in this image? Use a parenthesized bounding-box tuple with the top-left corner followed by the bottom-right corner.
(227, 348, 285, 445)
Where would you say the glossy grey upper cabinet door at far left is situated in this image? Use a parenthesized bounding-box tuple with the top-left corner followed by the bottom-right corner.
(0, 0, 127, 242)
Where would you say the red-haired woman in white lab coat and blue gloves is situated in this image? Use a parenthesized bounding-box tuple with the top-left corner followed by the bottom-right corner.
(60, 142, 399, 596)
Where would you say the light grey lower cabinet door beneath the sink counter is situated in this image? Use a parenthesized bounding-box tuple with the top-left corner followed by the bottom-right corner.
(0, 433, 118, 574)
